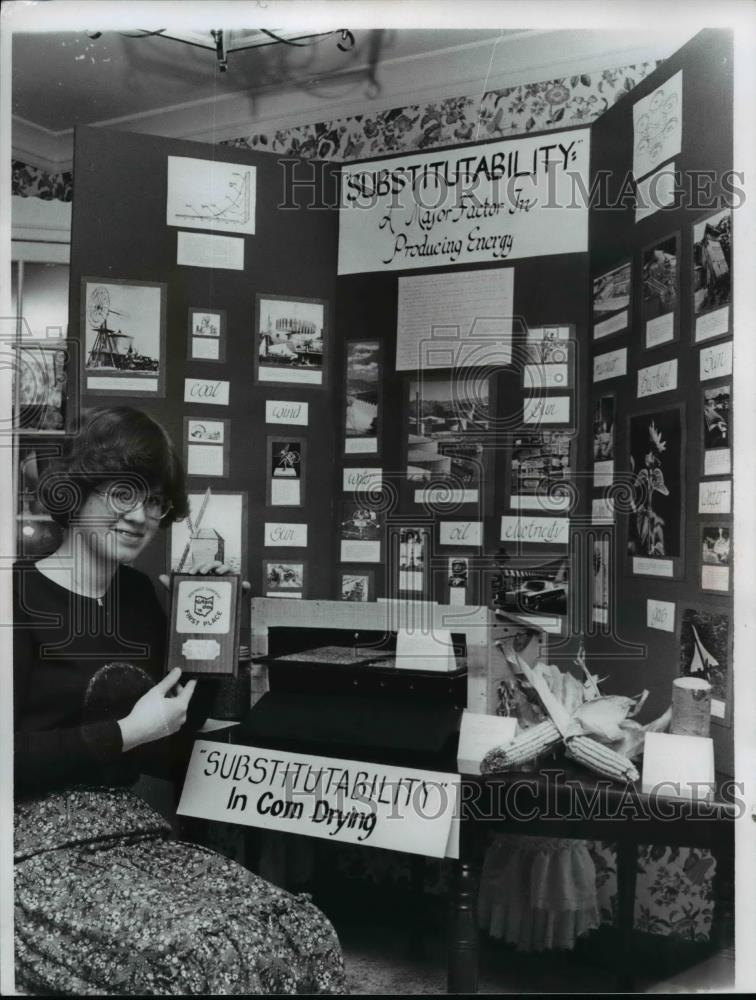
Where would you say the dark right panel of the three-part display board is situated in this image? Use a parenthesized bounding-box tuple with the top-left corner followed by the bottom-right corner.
(583, 30, 742, 774)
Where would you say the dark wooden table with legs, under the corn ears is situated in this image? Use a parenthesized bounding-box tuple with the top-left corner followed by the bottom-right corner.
(448, 764, 739, 993)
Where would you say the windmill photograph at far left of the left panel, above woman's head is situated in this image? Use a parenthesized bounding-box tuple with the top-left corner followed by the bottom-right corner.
(81, 278, 166, 396)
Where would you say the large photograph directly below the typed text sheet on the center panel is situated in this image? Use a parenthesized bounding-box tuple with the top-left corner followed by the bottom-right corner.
(407, 378, 490, 499)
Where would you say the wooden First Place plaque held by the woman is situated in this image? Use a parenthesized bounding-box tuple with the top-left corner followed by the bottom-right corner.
(166, 573, 242, 677)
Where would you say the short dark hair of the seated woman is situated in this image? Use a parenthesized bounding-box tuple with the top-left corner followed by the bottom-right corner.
(39, 406, 189, 527)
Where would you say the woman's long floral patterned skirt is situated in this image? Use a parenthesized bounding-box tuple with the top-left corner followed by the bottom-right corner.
(15, 788, 346, 996)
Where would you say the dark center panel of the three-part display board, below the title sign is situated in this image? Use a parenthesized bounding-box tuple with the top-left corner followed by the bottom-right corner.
(333, 129, 590, 640)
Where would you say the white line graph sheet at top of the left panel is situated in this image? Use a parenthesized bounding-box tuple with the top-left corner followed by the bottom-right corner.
(165, 156, 256, 236)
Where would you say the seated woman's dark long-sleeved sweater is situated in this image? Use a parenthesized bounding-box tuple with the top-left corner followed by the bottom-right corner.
(13, 560, 213, 795)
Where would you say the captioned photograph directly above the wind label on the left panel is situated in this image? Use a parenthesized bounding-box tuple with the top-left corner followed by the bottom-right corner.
(256, 295, 326, 386)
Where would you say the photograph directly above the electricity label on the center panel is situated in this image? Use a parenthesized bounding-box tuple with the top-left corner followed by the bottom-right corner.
(510, 430, 572, 509)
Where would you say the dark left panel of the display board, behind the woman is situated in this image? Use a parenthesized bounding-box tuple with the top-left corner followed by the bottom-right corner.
(69, 128, 337, 597)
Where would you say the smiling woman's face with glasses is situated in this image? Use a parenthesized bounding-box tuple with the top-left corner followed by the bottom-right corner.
(72, 483, 160, 563)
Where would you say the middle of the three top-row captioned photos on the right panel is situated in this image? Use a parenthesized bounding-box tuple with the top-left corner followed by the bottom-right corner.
(641, 233, 680, 350)
